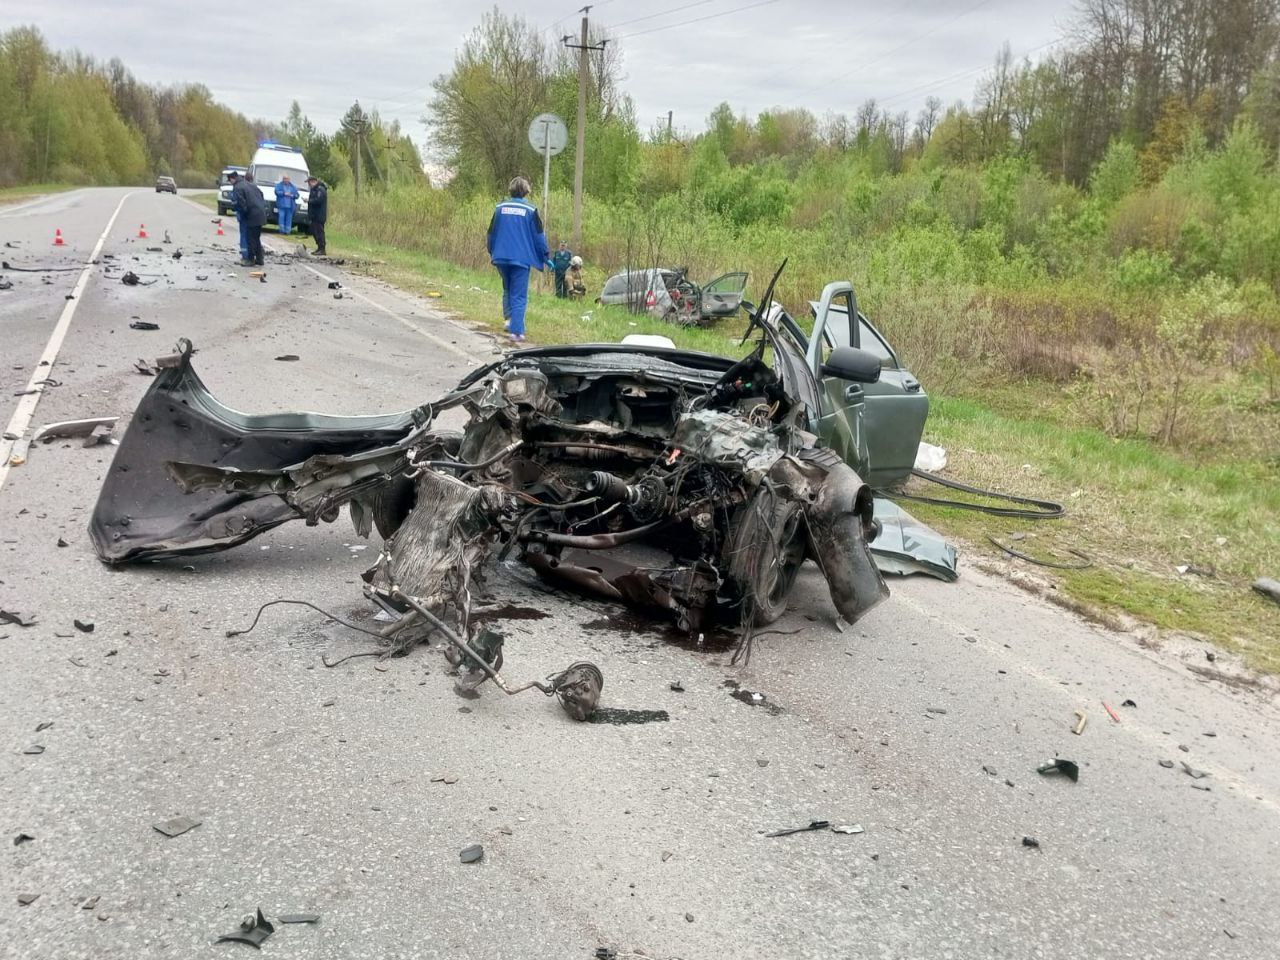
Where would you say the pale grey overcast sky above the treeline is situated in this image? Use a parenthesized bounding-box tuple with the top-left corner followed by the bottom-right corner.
(24, 0, 1073, 156)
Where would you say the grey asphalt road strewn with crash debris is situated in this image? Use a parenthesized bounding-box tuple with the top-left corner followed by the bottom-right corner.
(0, 189, 1280, 960)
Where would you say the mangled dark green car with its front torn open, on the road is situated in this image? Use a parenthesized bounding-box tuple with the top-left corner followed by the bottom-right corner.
(90, 270, 928, 718)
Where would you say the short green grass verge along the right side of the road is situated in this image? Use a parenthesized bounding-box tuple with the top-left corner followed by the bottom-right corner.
(192, 193, 1280, 673)
